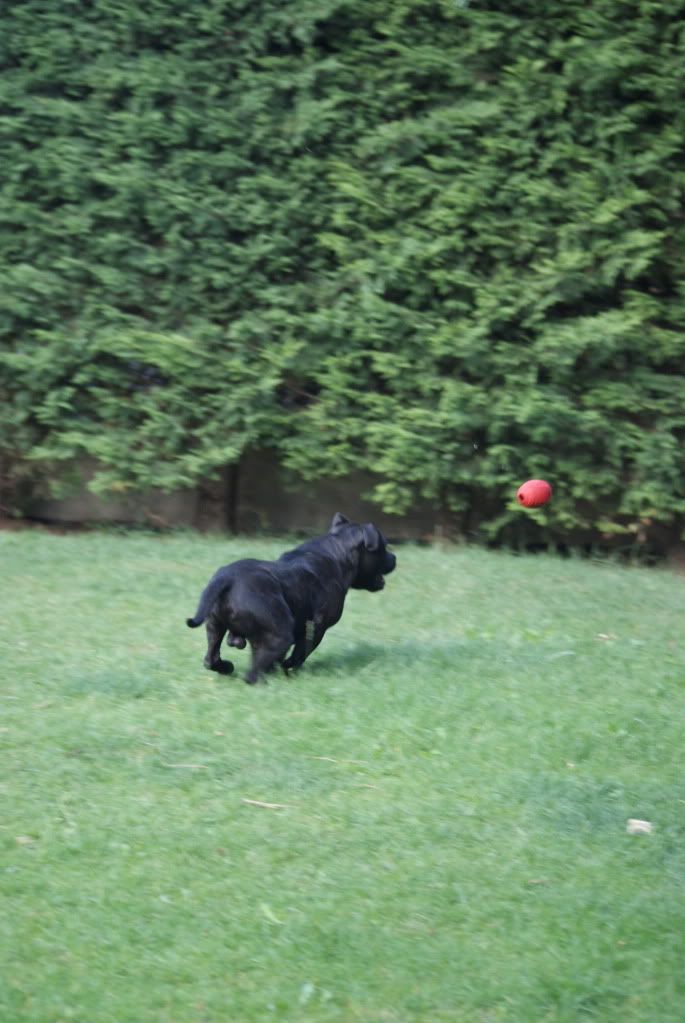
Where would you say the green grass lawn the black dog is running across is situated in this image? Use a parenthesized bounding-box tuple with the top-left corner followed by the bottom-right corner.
(0, 532, 685, 1023)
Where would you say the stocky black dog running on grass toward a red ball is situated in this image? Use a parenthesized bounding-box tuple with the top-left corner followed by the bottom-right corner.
(186, 512, 396, 684)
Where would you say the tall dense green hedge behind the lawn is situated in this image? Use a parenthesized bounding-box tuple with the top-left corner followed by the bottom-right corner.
(0, 0, 685, 536)
